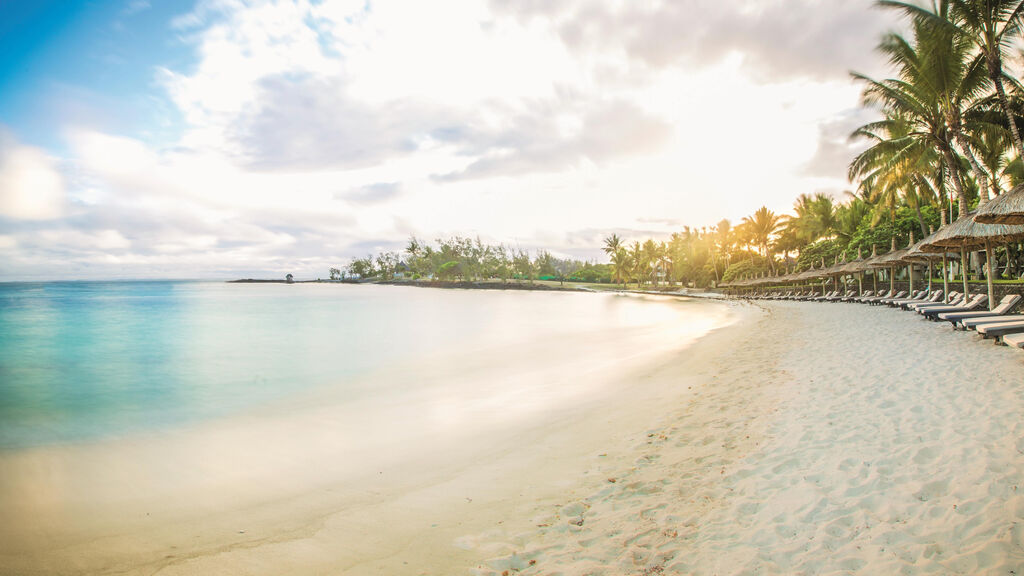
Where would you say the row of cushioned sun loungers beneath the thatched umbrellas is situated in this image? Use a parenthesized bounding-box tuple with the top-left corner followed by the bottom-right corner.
(752, 290, 1024, 348)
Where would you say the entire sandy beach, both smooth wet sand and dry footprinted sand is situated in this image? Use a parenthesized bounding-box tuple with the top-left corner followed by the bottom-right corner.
(0, 296, 1024, 575)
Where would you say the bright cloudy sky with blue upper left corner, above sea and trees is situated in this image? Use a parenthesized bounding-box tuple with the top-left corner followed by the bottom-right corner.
(0, 0, 896, 280)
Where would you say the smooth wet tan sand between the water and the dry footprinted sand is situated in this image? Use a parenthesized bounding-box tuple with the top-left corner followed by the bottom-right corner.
(0, 293, 741, 575)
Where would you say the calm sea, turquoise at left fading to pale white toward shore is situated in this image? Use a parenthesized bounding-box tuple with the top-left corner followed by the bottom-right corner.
(0, 282, 729, 449)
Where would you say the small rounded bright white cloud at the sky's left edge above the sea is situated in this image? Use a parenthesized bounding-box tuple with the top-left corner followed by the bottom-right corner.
(0, 133, 67, 220)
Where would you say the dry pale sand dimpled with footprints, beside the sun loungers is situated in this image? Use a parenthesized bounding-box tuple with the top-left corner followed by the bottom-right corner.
(473, 302, 1024, 576)
